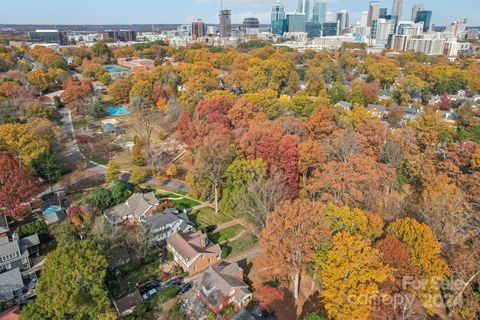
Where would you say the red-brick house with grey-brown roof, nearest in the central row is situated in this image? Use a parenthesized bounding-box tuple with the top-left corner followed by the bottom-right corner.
(198, 263, 252, 313)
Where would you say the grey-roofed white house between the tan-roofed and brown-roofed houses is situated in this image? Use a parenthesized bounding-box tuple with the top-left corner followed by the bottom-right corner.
(144, 208, 195, 242)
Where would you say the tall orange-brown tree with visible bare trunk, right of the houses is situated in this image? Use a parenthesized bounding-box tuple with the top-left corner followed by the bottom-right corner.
(258, 199, 330, 299)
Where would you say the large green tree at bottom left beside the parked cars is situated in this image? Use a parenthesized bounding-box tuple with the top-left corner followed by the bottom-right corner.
(21, 241, 115, 320)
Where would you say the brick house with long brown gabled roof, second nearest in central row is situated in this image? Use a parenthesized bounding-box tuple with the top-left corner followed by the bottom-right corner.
(167, 231, 221, 275)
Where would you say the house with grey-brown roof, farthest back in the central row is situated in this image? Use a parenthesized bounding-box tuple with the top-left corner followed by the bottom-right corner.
(104, 192, 160, 225)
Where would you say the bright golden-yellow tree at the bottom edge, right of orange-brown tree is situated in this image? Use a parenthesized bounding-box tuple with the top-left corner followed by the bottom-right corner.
(320, 231, 393, 319)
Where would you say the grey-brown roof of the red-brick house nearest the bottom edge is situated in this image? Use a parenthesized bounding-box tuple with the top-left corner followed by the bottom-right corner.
(200, 263, 251, 306)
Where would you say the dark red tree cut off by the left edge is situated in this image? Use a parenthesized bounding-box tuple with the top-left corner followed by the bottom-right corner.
(0, 152, 37, 219)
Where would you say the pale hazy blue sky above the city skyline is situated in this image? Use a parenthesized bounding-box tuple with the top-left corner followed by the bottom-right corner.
(0, 0, 480, 26)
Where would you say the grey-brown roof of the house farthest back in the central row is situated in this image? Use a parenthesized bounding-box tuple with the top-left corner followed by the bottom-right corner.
(105, 192, 159, 219)
